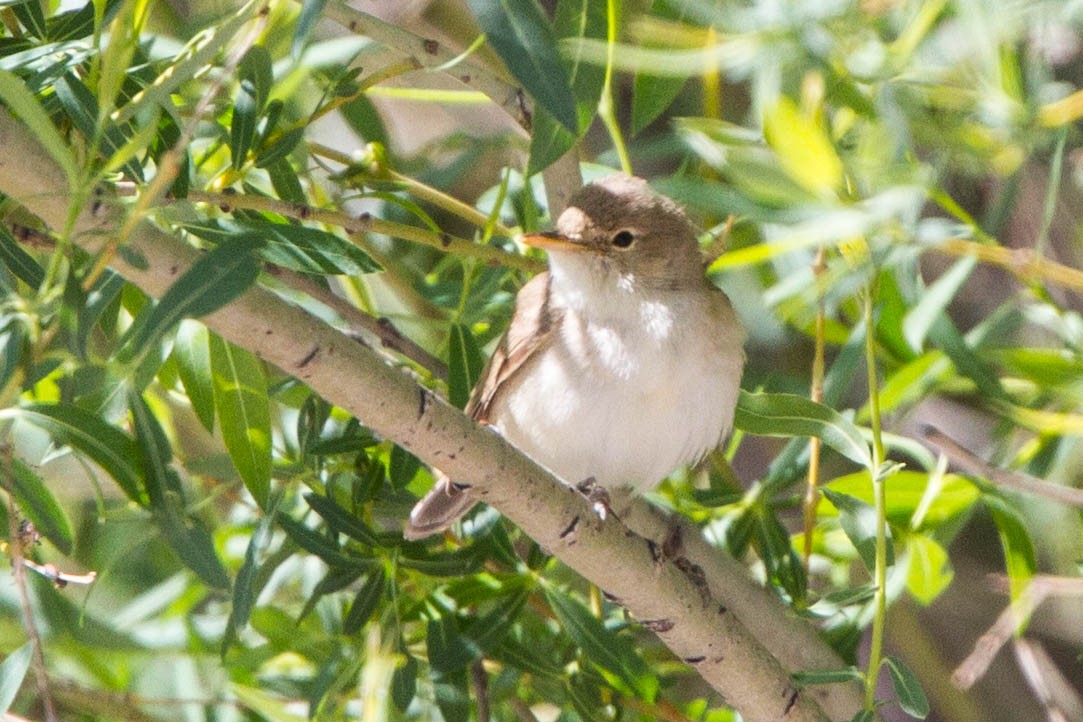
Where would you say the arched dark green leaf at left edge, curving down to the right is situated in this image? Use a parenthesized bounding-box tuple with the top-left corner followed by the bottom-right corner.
(0, 404, 146, 504)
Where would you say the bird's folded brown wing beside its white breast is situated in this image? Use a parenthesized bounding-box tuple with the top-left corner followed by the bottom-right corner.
(466, 272, 560, 423)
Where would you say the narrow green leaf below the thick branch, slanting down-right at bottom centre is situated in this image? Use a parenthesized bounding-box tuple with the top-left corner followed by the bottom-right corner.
(545, 588, 658, 703)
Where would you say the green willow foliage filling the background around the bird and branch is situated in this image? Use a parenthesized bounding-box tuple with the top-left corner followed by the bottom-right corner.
(0, 0, 1083, 721)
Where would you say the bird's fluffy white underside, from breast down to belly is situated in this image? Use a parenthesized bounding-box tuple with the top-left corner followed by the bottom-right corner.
(490, 273, 744, 491)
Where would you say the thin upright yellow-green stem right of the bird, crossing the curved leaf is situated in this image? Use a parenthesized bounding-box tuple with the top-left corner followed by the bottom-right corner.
(864, 281, 887, 711)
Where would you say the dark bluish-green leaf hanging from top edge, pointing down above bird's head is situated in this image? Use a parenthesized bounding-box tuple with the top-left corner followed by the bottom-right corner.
(469, 0, 578, 133)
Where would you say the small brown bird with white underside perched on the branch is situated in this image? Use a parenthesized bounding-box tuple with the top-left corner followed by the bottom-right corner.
(404, 173, 745, 539)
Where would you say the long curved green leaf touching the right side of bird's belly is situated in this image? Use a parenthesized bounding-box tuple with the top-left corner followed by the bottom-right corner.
(733, 390, 873, 469)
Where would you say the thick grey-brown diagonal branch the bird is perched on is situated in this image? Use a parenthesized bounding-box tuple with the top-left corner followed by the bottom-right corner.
(0, 113, 860, 722)
